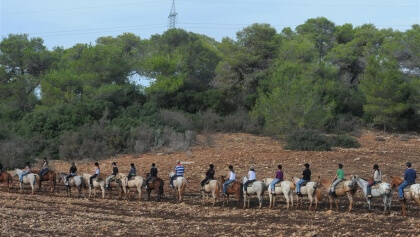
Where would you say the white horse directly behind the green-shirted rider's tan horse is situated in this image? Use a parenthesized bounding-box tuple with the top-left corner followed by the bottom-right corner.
(352, 175, 392, 213)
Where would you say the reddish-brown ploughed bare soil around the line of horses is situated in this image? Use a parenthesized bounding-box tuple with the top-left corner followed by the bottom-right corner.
(0, 131, 420, 236)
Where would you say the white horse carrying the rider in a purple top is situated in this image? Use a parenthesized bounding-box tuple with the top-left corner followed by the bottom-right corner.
(264, 178, 296, 210)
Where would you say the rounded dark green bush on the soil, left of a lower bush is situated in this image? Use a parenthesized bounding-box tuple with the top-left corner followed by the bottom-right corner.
(285, 129, 331, 151)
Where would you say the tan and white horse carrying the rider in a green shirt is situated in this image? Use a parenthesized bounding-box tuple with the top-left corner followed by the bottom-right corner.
(318, 177, 357, 212)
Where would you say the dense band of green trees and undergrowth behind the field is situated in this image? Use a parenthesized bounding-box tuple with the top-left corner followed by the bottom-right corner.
(0, 18, 420, 166)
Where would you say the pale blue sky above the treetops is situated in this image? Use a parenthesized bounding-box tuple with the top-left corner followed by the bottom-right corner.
(0, 0, 420, 49)
